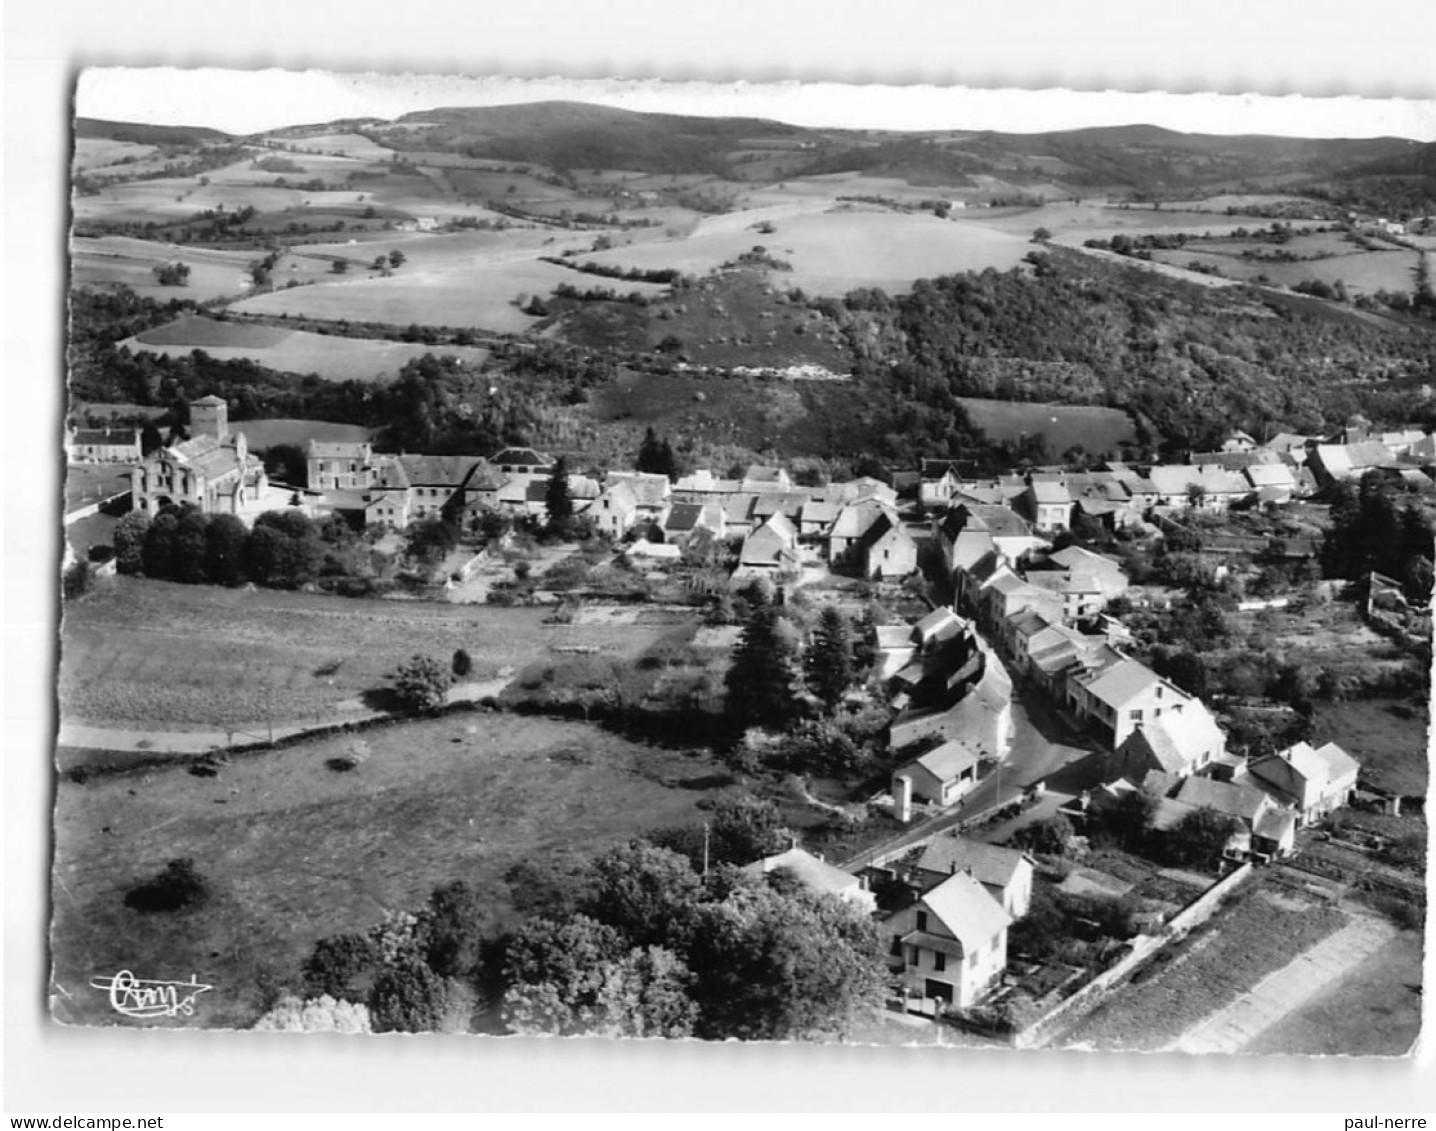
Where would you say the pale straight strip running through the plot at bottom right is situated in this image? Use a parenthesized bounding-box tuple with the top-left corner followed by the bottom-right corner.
(1162, 916, 1397, 1052)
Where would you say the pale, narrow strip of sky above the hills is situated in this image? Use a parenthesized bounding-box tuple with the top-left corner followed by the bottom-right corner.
(75, 67, 1436, 141)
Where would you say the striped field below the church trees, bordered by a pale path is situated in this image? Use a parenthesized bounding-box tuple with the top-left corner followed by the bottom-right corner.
(59, 577, 695, 731)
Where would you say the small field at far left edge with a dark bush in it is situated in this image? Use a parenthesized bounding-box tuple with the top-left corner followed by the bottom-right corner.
(70, 235, 258, 303)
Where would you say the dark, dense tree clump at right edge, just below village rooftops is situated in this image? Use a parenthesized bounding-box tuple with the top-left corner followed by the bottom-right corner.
(1321, 471, 1436, 604)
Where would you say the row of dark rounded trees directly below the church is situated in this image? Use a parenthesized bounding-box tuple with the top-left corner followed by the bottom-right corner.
(115, 505, 372, 588)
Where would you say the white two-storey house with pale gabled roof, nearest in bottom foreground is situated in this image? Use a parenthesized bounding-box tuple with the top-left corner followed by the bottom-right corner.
(883, 871, 1012, 1009)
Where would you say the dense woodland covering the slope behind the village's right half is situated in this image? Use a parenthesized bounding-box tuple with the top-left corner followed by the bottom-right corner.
(821, 248, 1436, 461)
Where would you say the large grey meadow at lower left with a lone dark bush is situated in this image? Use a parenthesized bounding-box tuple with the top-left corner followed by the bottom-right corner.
(52, 714, 724, 1026)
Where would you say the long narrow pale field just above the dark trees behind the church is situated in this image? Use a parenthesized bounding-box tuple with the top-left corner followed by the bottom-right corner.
(119, 316, 488, 380)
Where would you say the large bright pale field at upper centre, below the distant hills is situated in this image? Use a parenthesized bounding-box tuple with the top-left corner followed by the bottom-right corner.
(571, 208, 1031, 296)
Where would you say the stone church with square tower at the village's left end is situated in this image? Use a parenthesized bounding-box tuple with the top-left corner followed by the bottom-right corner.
(129, 396, 269, 515)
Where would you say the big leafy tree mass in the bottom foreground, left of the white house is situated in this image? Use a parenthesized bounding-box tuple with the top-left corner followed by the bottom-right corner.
(295, 841, 885, 1041)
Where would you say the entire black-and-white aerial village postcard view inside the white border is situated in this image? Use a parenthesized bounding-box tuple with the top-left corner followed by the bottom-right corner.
(7, 2, 1436, 1109)
